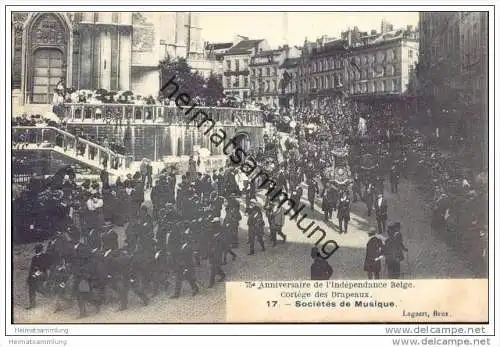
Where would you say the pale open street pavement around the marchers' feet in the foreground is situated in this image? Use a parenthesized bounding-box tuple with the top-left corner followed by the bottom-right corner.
(13, 181, 477, 323)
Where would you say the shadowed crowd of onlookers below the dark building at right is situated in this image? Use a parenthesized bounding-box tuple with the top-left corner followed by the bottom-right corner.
(409, 129, 488, 248)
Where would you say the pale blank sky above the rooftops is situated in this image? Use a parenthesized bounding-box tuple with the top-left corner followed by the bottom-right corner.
(199, 12, 418, 47)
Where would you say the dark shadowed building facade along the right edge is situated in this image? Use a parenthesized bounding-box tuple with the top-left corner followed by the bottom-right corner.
(418, 12, 488, 165)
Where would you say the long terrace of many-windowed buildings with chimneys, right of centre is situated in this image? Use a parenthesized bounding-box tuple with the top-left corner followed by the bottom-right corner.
(298, 21, 418, 111)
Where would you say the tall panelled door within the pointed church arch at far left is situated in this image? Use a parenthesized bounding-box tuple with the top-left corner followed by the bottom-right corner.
(31, 48, 64, 104)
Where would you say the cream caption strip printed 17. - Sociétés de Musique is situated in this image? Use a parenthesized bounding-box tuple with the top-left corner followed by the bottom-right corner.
(226, 279, 488, 323)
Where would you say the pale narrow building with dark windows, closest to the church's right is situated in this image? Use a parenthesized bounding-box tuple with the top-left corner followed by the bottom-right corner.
(222, 36, 269, 100)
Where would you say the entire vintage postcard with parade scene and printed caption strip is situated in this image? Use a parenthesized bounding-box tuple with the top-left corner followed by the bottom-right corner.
(6, 7, 493, 333)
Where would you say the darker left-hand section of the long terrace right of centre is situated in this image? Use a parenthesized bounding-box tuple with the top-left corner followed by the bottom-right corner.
(297, 36, 347, 107)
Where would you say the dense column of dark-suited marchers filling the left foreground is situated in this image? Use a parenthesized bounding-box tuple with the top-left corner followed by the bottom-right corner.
(22, 158, 296, 316)
